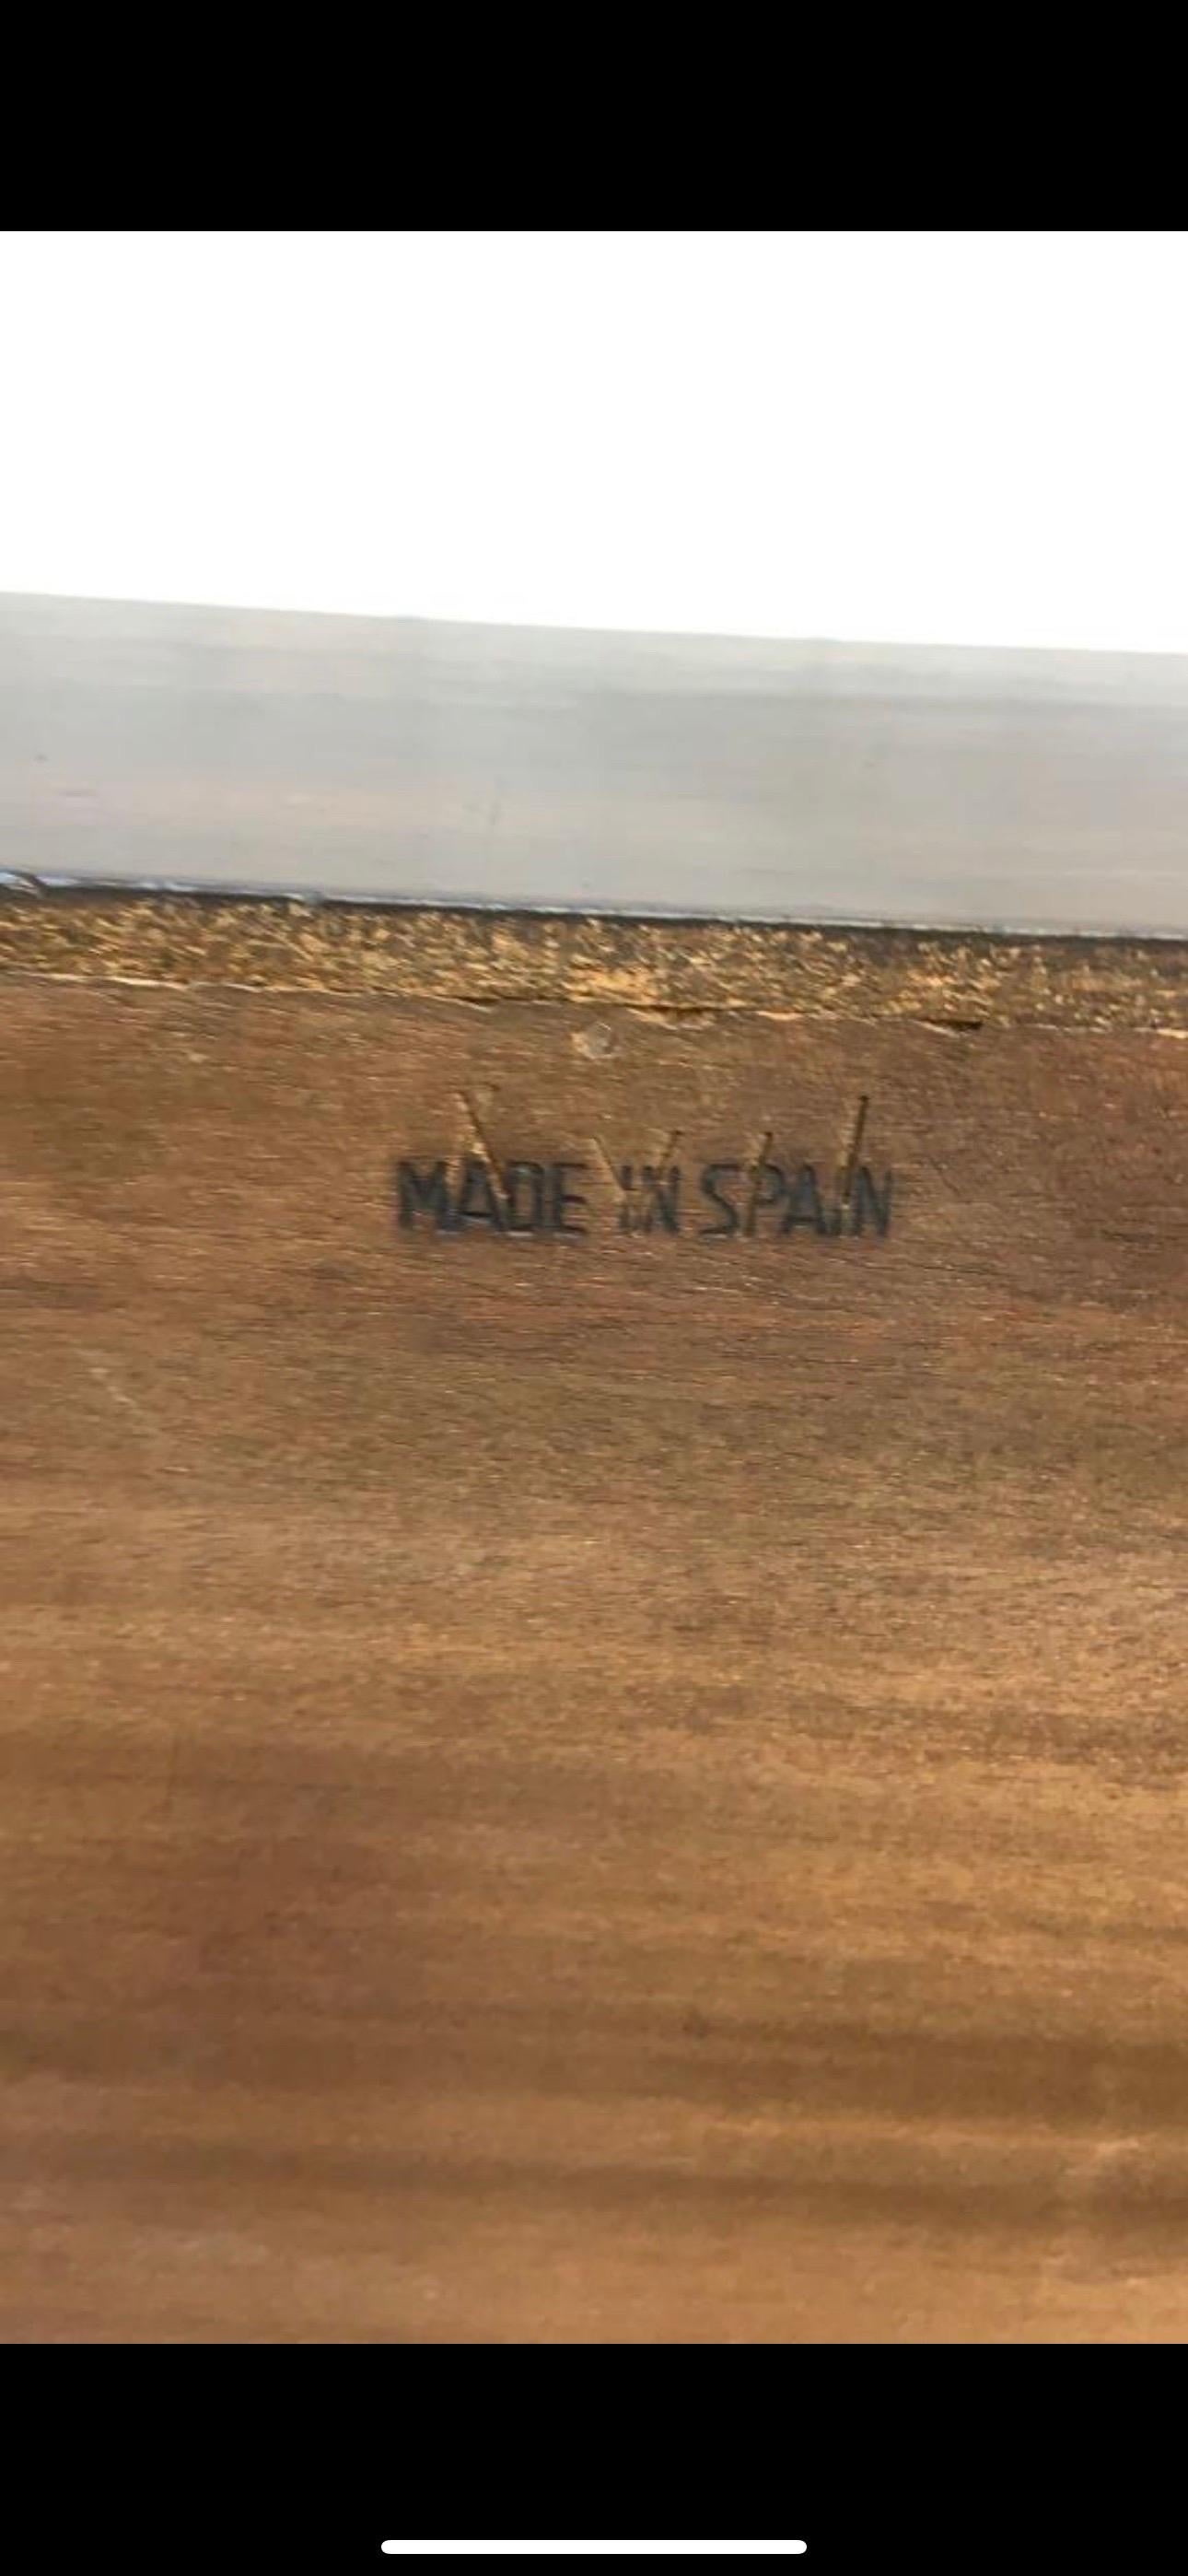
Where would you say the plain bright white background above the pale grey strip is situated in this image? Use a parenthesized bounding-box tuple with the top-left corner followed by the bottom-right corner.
(0, 232, 1188, 650)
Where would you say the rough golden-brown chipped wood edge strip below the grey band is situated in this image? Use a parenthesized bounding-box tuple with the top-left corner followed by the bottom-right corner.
(0, 881, 1188, 1036)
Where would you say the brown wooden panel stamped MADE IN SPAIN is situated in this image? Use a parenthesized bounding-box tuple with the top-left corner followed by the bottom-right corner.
(0, 907, 1188, 2342)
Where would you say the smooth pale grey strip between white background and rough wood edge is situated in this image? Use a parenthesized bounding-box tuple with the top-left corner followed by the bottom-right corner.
(11, 598, 1188, 935)
